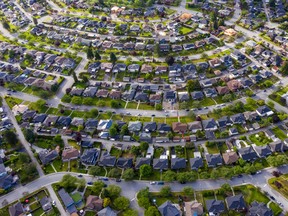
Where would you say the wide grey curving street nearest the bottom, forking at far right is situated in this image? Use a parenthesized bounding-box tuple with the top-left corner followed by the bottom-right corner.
(0, 166, 288, 211)
